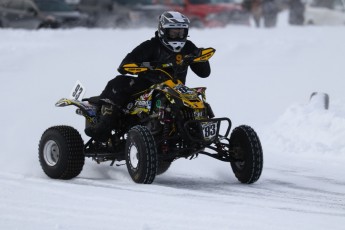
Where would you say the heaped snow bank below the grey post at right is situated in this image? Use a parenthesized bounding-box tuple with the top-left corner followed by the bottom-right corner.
(263, 94, 345, 157)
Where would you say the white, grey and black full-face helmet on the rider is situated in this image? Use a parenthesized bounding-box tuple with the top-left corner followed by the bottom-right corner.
(158, 11, 189, 52)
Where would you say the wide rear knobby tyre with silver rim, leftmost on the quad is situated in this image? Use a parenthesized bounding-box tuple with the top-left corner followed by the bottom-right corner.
(38, 125, 85, 180)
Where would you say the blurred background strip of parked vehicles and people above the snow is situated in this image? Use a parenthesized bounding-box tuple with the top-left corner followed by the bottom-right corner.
(0, 0, 345, 29)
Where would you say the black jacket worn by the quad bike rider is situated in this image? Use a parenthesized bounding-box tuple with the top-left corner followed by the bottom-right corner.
(118, 32, 211, 84)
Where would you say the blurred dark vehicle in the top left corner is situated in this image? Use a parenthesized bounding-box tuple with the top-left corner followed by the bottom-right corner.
(0, 0, 59, 29)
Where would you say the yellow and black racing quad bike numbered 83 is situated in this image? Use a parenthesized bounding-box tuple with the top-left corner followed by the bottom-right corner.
(39, 48, 263, 184)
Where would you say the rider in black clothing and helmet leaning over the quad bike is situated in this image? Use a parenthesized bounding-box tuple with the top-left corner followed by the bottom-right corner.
(85, 11, 211, 139)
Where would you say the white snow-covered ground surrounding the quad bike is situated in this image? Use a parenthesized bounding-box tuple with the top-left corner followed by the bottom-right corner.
(0, 12, 345, 230)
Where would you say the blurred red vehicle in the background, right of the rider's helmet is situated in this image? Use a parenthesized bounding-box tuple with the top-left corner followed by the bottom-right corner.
(153, 0, 250, 28)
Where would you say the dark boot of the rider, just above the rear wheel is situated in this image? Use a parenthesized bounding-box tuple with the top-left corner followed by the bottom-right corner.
(85, 104, 120, 141)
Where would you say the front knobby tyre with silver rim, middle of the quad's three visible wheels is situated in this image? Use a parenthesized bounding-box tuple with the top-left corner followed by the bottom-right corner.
(125, 125, 158, 184)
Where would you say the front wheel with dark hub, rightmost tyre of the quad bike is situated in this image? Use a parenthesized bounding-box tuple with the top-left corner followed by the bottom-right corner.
(230, 125, 263, 184)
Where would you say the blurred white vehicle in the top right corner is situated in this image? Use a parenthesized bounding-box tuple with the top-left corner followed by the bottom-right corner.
(304, 0, 345, 25)
